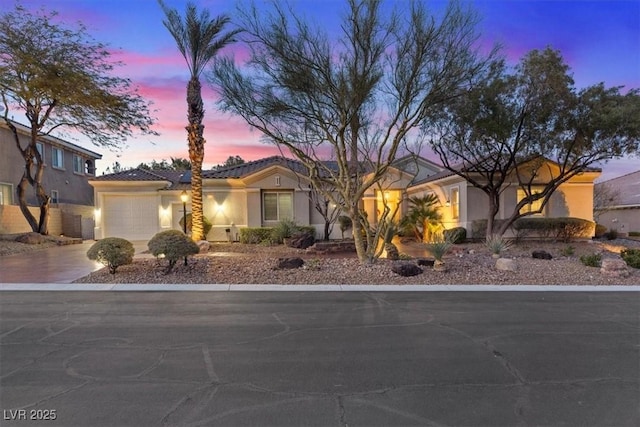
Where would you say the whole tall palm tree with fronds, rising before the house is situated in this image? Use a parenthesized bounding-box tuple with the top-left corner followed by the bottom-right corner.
(158, 0, 240, 241)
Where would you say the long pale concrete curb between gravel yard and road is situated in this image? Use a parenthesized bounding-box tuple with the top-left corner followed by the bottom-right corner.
(0, 283, 640, 292)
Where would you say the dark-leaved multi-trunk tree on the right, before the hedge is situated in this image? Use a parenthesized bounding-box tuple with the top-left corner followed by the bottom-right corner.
(424, 48, 640, 241)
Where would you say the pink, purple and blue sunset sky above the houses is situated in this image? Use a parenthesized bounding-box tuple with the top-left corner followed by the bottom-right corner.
(8, 0, 640, 181)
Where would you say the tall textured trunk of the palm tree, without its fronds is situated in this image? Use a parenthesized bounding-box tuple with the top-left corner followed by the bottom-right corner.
(187, 76, 206, 241)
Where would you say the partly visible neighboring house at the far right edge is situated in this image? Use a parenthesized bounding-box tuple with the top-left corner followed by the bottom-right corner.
(596, 170, 640, 234)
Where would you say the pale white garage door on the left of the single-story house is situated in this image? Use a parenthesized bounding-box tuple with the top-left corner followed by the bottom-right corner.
(102, 195, 159, 240)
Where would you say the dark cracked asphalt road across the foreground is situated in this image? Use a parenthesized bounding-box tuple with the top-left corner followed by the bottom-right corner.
(0, 292, 640, 427)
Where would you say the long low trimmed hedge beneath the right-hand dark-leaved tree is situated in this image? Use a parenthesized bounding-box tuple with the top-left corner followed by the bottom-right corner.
(513, 217, 595, 242)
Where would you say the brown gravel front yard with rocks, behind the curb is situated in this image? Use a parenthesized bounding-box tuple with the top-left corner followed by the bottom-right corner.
(71, 239, 640, 285)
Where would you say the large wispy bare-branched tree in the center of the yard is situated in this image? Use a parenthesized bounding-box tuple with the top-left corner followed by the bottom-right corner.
(210, 0, 492, 262)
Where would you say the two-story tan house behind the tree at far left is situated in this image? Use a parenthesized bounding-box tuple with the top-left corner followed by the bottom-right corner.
(0, 120, 102, 238)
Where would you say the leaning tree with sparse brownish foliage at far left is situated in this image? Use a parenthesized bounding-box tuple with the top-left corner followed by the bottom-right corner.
(0, 5, 155, 234)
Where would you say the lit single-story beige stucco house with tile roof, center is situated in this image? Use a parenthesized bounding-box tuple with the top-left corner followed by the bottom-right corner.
(89, 156, 599, 241)
